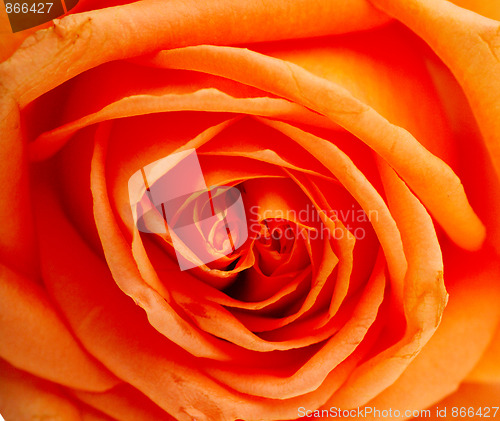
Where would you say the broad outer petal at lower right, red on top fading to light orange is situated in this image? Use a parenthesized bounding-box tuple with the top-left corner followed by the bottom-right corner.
(326, 246, 500, 419)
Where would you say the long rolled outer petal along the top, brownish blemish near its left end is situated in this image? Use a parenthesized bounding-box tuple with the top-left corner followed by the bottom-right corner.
(0, 0, 388, 107)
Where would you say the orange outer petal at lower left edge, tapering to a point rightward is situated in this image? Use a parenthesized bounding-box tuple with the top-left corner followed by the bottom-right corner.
(0, 265, 118, 391)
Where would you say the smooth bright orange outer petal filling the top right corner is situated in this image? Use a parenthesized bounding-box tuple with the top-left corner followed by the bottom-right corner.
(372, 0, 500, 182)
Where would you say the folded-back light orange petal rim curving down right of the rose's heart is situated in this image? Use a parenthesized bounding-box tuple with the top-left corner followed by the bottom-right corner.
(329, 160, 447, 408)
